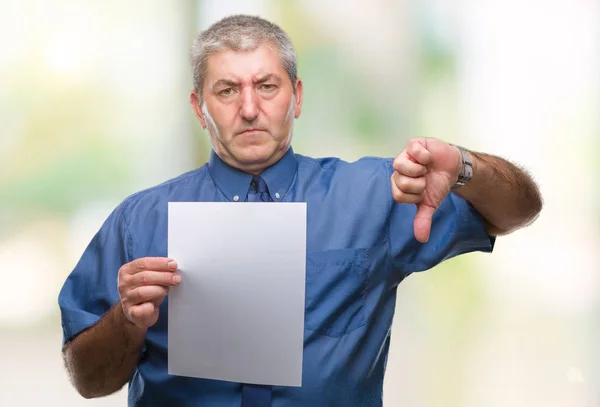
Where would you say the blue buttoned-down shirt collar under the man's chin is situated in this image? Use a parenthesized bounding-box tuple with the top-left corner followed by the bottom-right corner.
(208, 147, 298, 202)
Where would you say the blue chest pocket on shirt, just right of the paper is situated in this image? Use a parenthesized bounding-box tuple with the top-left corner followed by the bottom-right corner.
(305, 249, 369, 338)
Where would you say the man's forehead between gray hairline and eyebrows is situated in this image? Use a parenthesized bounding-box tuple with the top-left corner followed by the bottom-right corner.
(206, 45, 287, 85)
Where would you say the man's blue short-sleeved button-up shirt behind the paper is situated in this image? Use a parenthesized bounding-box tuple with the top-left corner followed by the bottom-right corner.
(58, 148, 494, 407)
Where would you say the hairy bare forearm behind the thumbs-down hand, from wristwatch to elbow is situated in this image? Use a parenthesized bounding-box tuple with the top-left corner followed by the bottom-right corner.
(456, 152, 542, 235)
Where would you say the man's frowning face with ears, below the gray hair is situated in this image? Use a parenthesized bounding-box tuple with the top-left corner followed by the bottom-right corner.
(190, 45, 302, 174)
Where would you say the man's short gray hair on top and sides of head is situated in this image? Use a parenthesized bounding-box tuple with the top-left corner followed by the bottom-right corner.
(190, 15, 297, 100)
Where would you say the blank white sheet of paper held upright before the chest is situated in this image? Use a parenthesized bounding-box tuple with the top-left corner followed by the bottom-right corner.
(168, 202, 306, 386)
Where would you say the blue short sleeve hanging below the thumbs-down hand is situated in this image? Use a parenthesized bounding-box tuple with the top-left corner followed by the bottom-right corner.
(388, 163, 496, 278)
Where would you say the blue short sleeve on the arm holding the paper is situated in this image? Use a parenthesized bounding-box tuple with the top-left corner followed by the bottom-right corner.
(58, 206, 130, 344)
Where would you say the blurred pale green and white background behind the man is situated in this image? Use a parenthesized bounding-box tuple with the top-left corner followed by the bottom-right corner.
(0, 0, 600, 407)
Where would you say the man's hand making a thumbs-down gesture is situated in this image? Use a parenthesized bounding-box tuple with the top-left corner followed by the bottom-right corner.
(391, 138, 462, 243)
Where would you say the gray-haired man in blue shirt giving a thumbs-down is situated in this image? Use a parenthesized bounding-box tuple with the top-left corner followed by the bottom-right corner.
(59, 15, 542, 407)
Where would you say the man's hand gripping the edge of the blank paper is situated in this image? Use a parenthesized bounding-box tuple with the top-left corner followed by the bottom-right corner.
(118, 257, 181, 328)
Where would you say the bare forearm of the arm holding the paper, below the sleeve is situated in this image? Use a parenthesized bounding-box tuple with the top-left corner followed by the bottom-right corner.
(63, 304, 146, 398)
